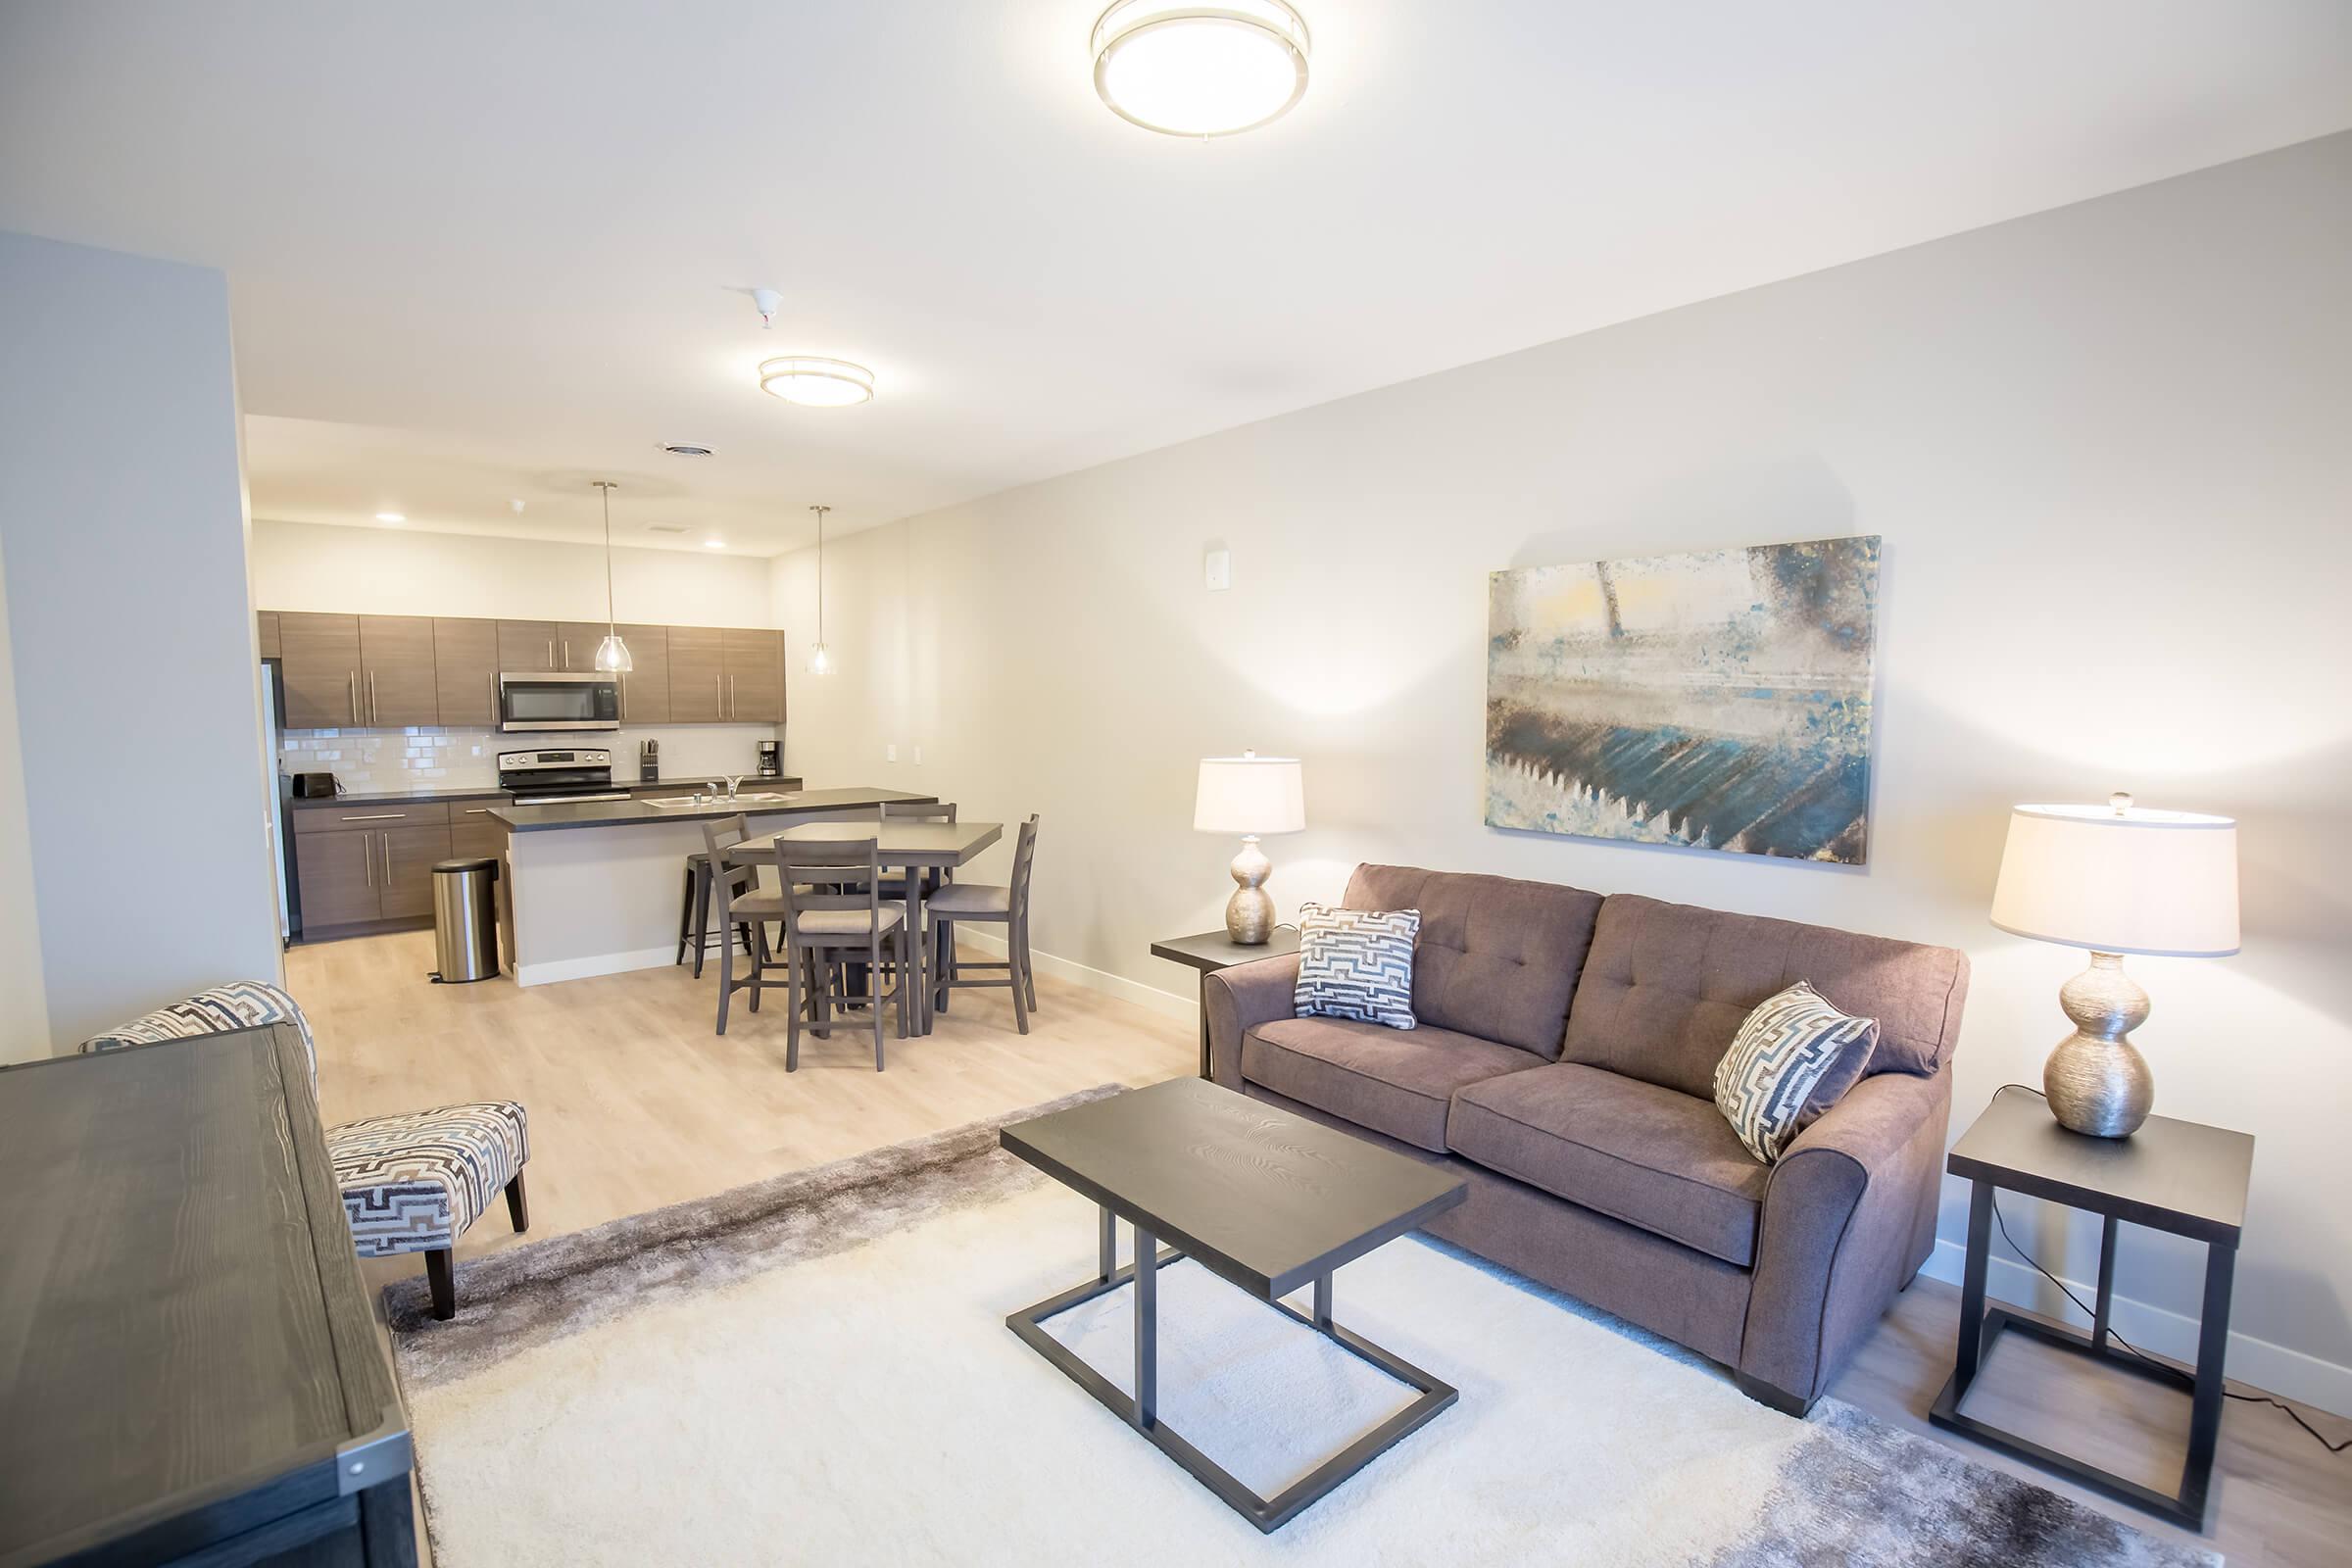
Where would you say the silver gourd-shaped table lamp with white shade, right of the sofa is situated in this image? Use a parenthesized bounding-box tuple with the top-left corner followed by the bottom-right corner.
(1992, 792, 2236, 1138)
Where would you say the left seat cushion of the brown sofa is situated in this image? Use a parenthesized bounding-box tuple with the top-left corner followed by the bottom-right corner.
(1242, 1018, 1533, 1154)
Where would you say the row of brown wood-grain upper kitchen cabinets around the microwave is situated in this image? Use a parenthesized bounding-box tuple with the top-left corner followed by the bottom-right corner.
(257, 609, 783, 729)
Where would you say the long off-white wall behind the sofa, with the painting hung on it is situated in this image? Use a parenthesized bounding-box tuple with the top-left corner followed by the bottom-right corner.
(776, 136, 2352, 1410)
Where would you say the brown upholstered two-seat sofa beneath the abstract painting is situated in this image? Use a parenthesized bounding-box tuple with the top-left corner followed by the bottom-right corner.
(1204, 865, 1969, 1413)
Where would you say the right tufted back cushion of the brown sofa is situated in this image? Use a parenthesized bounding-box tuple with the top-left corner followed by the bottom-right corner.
(1562, 894, 1969, 1098)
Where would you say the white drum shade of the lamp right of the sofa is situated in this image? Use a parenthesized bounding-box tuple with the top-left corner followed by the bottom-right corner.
(1992, 807, 2236, 959)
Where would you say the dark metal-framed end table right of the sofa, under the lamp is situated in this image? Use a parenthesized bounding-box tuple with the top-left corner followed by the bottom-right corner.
(1929, 1084, 2253, 1531)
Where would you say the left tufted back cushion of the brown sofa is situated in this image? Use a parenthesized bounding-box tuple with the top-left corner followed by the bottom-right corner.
(1341, 865, 1601, 1060)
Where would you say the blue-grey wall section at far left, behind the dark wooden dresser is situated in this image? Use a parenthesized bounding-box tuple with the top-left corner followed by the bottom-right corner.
(0, 235, 280, 1049)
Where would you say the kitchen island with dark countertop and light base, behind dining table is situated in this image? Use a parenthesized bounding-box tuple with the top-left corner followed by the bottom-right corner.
(489, 780, 936, 985)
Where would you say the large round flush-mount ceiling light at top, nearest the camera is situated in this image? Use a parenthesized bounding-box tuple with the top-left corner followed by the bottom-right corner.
(1092, 0, 1310, 136)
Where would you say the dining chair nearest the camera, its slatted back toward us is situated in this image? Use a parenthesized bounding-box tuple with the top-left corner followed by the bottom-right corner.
(760, 839, 915, 1072)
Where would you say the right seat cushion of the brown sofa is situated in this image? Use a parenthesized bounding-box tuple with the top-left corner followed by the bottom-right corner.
(1446, 1062, 1771, 1267)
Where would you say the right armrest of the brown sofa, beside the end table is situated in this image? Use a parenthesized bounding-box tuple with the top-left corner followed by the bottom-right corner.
(1739, 1065, 1952, 1410)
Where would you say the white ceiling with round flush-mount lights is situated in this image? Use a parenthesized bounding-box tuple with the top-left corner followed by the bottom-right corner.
(0, 0, 2352, 553)
